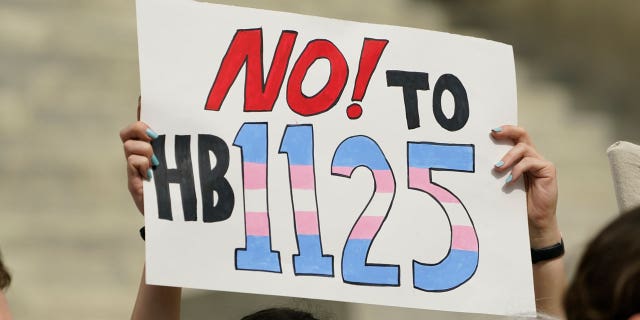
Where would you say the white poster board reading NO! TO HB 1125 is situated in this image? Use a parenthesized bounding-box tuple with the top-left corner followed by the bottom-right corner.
(137, 0, 535, 314)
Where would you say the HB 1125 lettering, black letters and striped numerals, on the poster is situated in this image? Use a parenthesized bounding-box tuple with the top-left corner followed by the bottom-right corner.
(152, 123, 479, 292)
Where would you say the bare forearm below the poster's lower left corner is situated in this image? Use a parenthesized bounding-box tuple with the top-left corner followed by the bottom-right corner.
(131, 269, 182, 320)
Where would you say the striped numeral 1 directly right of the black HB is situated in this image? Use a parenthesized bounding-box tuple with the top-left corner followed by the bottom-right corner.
(233, 123, 281, 272)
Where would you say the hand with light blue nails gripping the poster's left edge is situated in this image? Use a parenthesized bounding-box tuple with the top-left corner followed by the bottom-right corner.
(120, 121, 158, 214)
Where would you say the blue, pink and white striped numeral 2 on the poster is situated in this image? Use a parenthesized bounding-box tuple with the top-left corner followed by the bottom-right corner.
(331, 136, 400, 286)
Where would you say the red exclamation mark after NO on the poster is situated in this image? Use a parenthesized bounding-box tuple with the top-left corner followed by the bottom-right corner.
(347, 38, 389, 120)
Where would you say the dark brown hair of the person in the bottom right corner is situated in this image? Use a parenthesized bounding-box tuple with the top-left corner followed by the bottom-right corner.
(564, 207, 640, 320)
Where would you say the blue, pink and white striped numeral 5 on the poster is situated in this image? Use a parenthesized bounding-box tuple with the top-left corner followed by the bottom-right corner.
(407, 142, 478, 292)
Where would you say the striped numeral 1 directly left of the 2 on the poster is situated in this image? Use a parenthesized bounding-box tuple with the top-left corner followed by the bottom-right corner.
(280, 125, 333, 276)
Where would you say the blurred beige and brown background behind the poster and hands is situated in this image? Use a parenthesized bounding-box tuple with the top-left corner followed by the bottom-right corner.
(0, 0, 640, 320)
